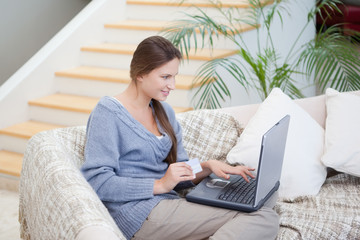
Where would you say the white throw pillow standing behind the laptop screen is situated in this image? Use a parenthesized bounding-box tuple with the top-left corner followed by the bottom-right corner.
(227, 88, 326, 198)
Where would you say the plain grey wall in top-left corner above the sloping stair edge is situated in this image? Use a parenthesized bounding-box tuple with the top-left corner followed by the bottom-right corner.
(0, 0, 90, 85)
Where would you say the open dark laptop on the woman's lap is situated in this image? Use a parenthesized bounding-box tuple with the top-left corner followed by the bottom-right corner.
(186, 115, 290, 212)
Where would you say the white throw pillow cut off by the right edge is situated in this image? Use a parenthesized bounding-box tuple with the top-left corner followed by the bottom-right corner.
(322, 88, 360, 177)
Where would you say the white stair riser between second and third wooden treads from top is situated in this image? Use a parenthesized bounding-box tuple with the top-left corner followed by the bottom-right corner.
(104, 28, 236, 49)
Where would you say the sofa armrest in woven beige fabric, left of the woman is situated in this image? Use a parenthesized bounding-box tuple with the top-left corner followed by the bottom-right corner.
(19, 127, 125, 239)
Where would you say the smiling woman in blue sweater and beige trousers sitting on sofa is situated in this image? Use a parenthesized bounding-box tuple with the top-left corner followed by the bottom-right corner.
(82, 36, 278, 239)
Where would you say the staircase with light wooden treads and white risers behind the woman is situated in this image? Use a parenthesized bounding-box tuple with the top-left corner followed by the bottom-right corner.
(0, 0, 251, 182)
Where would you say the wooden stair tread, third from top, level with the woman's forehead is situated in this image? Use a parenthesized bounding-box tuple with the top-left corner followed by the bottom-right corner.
(81, 43, 238, 61)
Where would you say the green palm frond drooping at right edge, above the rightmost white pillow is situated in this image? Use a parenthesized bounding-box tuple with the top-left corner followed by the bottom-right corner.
(300, 26, 360, 91)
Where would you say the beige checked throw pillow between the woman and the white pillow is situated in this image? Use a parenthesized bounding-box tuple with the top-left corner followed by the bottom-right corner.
(176, 110, 242, 162)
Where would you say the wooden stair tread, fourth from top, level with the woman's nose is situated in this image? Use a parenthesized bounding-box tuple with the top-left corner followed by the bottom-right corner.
(55, 66, 199, 90)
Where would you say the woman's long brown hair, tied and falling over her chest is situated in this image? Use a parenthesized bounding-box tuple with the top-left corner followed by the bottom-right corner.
(130, 36, 182, 164)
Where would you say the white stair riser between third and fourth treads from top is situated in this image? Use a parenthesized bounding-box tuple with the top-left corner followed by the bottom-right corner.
(81, 51, 205, 76)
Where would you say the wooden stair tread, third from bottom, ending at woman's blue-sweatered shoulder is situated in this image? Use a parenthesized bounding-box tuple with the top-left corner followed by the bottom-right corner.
(29, 93, 99, 113)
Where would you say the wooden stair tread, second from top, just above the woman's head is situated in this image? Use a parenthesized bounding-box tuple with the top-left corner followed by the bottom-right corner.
(105, 19, 255, 33)
